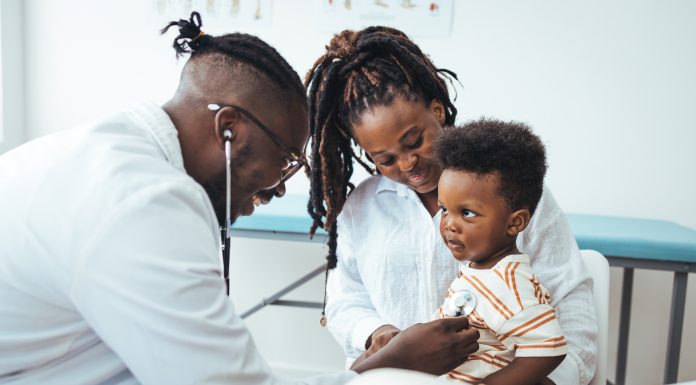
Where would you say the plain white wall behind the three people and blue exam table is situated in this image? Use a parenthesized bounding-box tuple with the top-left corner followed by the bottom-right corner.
(13, 0, 696, 384)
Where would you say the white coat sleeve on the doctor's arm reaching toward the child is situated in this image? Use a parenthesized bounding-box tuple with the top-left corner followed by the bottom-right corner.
(70, 180, 356, 385)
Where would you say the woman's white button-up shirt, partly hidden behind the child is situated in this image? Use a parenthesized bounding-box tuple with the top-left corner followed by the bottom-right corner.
(327, 176, 597, 385)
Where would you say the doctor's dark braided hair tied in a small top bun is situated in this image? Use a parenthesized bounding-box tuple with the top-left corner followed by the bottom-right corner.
(160, 12, 306, 104)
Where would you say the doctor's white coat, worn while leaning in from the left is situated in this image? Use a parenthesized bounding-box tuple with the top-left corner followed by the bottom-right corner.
(0, 104, 356, 385)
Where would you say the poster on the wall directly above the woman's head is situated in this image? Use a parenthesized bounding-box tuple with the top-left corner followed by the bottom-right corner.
(313, 0, 454, 38)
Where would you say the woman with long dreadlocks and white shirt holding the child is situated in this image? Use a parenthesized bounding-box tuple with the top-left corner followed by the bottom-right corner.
(305, 27, 597, 384)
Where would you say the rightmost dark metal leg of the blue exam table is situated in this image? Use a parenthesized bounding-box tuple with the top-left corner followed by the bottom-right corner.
(664, 272, 689, 384)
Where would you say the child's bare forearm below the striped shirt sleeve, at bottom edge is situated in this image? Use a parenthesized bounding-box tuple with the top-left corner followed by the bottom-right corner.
(485, 354, 565, 385)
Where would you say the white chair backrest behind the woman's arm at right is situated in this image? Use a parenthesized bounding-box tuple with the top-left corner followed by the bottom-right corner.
(580, 250, 609, 385)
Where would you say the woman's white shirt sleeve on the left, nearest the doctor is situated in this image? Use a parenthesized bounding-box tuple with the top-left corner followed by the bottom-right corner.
(326, 209, 388, 362)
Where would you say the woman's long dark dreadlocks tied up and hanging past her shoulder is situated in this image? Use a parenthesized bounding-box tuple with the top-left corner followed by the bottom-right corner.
(305, 27, 457, 320)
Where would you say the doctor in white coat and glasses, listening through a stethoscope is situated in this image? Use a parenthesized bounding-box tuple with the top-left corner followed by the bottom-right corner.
(0, 13, 478, 385)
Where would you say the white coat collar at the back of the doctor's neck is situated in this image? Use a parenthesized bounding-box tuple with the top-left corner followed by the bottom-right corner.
(129, 102, 186, 172)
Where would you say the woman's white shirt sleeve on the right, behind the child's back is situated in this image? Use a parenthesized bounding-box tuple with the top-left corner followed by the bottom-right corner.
(517, 186, 597, 385)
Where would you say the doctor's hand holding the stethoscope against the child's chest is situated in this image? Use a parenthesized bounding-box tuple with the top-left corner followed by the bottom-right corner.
(352, 317, 479, 375)
